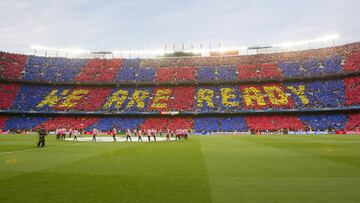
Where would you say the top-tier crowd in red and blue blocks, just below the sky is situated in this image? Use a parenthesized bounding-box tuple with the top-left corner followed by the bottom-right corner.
(0, 43, 360, 84)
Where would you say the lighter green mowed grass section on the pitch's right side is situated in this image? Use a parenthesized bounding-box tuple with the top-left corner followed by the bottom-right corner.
(201, 136, 360, 202)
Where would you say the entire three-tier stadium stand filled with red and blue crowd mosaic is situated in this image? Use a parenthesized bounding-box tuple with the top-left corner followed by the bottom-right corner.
(0, 43, 360, 133)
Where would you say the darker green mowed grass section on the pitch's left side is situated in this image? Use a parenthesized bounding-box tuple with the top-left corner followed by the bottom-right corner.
(0, 135, 210, 202)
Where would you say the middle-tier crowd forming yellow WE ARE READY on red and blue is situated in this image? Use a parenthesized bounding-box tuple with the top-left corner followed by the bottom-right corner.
(0, 76, 360, 113)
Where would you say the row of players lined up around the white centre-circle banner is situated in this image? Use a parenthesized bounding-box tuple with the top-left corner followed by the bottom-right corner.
(55, 128, 189, 142)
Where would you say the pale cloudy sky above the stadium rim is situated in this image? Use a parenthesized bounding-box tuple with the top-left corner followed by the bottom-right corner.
(0, 0, 360, 53)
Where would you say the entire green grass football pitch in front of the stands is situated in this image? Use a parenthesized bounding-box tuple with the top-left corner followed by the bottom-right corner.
(0, 135, 360, 203)
